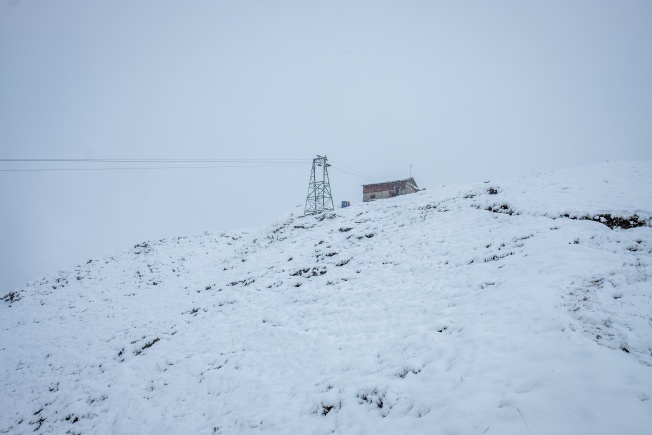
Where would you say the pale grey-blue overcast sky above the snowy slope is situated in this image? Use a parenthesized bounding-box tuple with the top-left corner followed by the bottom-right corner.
(0, 0, 652, 296)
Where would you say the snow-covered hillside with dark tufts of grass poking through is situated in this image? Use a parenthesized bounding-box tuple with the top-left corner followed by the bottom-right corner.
(0, 162, 652, 435)
